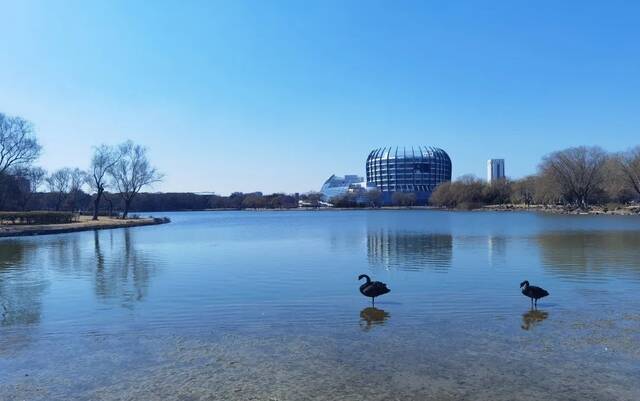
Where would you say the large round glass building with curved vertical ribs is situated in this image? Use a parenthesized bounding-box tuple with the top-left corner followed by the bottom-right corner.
(367, 146, 451, 205)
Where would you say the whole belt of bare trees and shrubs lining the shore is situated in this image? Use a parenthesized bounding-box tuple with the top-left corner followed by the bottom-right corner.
(0, 109, 640, 216)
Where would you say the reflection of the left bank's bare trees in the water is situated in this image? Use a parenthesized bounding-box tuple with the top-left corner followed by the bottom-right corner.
(0, 229, 157, 327)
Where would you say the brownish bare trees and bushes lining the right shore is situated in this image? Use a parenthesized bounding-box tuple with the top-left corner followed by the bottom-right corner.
(430, 146, 640, 209)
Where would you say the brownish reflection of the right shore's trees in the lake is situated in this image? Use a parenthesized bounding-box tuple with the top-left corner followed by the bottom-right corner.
(537, 231, 640, 279)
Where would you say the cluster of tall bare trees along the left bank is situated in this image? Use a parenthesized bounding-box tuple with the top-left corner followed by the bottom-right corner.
(0, 113, 163, 220)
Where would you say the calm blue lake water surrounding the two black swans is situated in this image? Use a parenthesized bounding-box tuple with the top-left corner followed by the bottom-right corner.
(0, 211, 640, 400)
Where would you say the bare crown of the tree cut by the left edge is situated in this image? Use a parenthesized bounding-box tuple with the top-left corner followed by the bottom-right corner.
(0, 113, 41, 175)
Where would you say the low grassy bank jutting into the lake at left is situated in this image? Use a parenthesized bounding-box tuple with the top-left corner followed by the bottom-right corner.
(0, 216, 169, 238)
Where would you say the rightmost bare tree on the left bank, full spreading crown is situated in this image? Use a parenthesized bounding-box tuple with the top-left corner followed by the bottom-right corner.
(109, 141, 163, 219)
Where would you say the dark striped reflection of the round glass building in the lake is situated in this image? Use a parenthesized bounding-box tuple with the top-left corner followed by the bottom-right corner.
(367, 230, 453, 271)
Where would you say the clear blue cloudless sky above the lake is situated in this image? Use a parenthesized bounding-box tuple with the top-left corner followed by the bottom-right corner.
(0, 0, 640, 194)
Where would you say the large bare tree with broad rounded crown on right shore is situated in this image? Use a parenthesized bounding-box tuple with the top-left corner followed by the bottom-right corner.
(540, 146, 607, 208)
